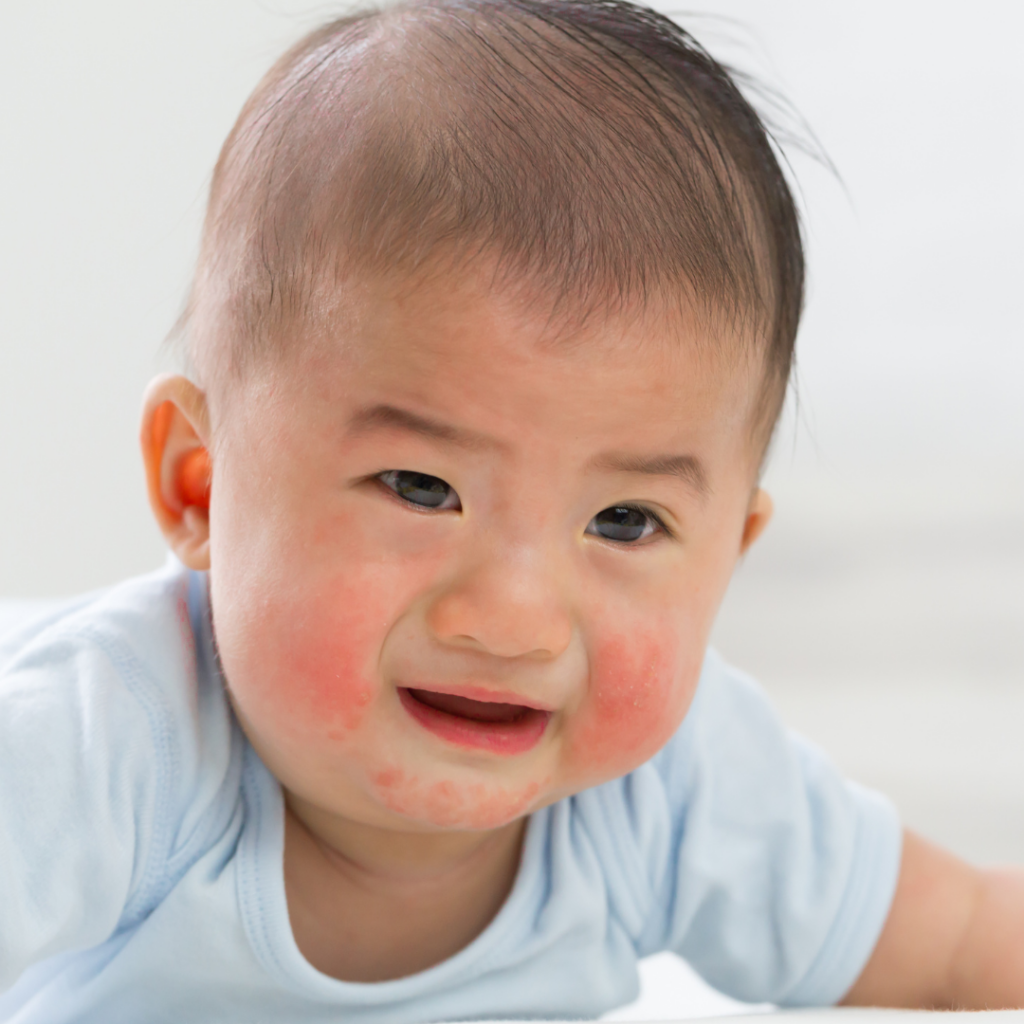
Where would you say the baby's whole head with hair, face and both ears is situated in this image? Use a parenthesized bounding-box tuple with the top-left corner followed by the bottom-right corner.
(143, 0, 803, 829)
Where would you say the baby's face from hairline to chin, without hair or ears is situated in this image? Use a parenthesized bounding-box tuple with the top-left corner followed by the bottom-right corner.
(210, 274, 770, 829)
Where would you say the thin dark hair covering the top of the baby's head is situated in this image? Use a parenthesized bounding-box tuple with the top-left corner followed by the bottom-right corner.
(185, 0, 804, 432)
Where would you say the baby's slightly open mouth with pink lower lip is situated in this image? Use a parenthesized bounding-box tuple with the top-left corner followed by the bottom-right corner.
(398, 687, 551, 754)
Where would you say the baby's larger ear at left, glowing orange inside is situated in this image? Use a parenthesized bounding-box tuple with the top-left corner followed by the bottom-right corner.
(139, 374, 212, 569)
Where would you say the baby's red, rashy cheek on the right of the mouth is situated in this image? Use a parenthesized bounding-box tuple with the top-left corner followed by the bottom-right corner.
(567, 625, 703, 783)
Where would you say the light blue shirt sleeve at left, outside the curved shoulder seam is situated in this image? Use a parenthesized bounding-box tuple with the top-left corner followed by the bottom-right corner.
(0, 635, 161, 991)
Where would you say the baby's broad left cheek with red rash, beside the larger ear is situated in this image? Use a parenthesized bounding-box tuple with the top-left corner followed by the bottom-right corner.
(211, 471, 456, 743)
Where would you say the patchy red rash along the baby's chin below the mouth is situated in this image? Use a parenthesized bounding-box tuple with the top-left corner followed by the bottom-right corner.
(372, 768, 547, 829)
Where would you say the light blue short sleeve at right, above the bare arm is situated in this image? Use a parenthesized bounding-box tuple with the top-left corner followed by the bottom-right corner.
(642, 652, 902, 1006)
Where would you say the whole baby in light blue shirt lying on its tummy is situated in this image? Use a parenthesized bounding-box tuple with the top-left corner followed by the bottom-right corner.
(0, 0, 1024, 1024)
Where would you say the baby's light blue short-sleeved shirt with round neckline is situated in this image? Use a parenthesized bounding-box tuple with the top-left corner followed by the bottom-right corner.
(0, 563, 900, 1024)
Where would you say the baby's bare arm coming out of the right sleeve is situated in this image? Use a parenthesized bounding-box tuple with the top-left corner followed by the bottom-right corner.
(843, 833, 1024, 1010)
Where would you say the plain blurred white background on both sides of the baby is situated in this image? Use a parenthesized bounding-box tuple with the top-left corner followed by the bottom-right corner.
(0, 0, 1024, 1015)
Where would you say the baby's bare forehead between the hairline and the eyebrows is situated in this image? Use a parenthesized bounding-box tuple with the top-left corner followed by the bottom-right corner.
(245, 267, 759, 473)
